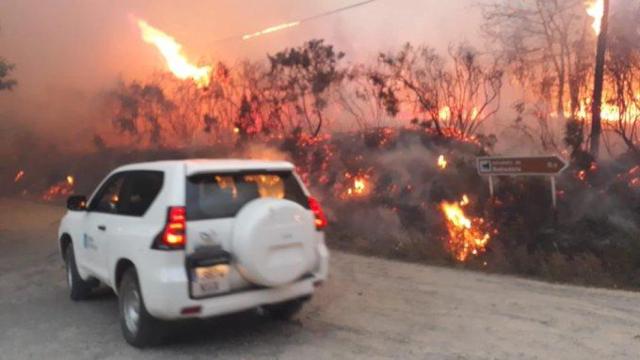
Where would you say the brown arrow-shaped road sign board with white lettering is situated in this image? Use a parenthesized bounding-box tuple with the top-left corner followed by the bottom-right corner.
(477, 155, 568, 176)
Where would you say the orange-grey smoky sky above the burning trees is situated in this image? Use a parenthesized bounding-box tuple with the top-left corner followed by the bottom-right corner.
(0, 0, 480, 146)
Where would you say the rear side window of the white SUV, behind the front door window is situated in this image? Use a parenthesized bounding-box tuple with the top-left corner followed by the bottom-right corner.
(118, 170, 164, 216)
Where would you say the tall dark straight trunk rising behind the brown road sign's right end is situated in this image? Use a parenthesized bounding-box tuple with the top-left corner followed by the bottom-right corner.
(590, 0, 609, 159)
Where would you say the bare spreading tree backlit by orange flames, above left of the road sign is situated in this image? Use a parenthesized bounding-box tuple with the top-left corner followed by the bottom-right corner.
(371, 44, 502, 139)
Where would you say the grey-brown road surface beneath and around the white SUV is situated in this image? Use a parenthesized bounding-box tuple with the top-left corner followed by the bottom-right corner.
(0, 199, 640, 359)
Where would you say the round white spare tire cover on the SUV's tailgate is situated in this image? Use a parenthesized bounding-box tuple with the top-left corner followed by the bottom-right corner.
(231, 198, 317, 286)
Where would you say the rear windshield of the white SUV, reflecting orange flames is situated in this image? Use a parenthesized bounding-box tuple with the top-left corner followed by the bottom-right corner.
(187, 171, 308, 220)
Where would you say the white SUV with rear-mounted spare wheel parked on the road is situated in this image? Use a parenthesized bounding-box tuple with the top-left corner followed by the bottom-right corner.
(58, 160, 329, 346)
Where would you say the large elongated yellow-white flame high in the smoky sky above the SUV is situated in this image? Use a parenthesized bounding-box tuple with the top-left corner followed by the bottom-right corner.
(138, 20, 211, 87)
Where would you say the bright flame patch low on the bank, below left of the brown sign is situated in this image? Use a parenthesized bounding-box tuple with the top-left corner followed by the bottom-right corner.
(440, 195, 491, 261)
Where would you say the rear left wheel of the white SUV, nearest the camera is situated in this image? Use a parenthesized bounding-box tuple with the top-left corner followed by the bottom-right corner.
(118, 267, 163, 348)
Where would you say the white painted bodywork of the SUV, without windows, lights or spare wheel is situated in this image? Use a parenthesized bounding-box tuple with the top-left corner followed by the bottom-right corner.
(58, 160, 329, 320)
